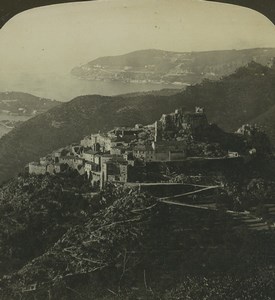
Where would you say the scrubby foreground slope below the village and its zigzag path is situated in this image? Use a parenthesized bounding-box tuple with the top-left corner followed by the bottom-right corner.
(0, 170, 275, 300)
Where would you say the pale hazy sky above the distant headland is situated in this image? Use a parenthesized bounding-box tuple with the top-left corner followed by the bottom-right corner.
(0, 0, 275, 73)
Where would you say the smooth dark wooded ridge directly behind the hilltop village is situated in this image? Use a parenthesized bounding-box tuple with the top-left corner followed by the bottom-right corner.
(0, 63, 275, 182)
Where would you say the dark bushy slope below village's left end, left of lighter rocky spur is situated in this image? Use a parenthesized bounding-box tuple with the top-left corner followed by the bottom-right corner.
(0, 174, 93, 275)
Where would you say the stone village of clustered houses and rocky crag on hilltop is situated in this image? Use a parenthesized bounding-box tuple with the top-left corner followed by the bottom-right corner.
(28, 107, 256, 190)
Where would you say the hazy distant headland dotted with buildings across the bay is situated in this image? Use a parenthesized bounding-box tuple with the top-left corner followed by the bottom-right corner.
(72, 48, 275, 86)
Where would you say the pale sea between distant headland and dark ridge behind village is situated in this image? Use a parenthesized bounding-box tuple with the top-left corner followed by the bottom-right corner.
(0, 72, 182, 102)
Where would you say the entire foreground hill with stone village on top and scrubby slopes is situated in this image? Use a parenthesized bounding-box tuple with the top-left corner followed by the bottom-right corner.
(0, 107, 275, 299)
